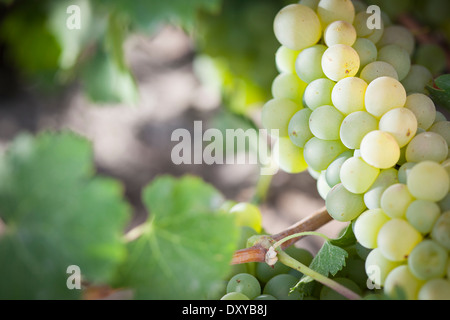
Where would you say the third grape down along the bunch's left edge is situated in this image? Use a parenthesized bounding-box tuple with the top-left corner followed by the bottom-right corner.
(272, 73, 306, 105)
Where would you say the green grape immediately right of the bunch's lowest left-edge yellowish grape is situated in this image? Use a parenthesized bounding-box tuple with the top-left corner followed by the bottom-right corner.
(303, 137, 347, 171)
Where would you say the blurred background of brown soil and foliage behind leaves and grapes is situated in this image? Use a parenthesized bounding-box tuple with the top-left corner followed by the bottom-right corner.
(0, 0, 450, 251)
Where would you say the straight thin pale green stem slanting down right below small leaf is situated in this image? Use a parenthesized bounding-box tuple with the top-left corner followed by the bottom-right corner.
(278, 251, 361, 300)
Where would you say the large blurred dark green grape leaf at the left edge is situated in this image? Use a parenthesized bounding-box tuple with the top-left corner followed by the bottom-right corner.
(0, 132, 129, 299)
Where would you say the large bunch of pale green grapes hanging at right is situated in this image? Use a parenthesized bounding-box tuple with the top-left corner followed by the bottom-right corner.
(261, 0, 450, 299)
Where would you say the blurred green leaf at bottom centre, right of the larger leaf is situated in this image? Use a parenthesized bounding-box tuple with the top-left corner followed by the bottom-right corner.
(118, 176, 239, 300)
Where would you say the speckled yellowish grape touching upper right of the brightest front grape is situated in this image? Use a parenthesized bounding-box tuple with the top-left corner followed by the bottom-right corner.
(379, 108, 417, 148)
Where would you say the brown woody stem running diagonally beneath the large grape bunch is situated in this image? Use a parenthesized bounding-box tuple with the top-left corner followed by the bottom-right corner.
(231, 207, 332, 264)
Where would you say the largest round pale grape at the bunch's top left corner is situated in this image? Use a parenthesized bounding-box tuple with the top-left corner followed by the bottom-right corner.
(273, 4, 322, 50)
